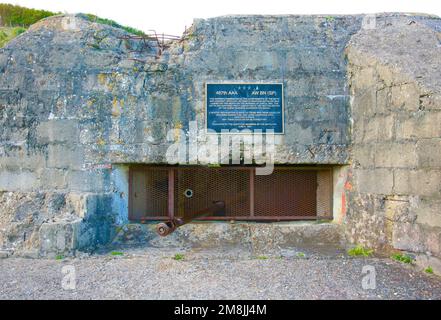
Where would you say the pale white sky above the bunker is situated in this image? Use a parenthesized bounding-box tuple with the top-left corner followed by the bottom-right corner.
(0, 0, 441, 36)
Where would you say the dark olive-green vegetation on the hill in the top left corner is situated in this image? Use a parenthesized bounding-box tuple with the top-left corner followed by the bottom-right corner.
(0, 3, 57, 27)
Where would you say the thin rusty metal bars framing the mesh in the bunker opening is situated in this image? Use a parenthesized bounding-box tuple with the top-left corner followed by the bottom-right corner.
(128, 164, 332, 222)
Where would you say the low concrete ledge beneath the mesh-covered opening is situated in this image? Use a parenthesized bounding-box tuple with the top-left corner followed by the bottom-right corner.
(112, 222, 345, 253)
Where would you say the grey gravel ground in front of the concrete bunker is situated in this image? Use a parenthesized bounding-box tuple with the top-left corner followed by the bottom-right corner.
(0, 248, 441, 299)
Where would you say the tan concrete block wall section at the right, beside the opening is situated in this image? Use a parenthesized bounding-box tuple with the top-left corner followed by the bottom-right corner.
(346, 17, 441, 272)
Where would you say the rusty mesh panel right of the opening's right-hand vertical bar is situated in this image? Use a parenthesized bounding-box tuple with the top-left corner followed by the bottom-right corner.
(255, 169, 317, 217)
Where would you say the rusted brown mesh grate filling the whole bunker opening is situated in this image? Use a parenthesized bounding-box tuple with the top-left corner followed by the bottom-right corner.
(129, 166, 332, 220)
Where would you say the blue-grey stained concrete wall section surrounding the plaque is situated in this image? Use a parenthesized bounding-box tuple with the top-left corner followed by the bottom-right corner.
(0, 16, 361, 254)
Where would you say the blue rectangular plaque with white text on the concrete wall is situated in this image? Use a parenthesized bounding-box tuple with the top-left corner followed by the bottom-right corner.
(206, 83, 284, 134)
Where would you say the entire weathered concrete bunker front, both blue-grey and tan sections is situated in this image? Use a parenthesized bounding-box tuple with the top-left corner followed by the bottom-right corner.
(0, 15, 441, 256)
